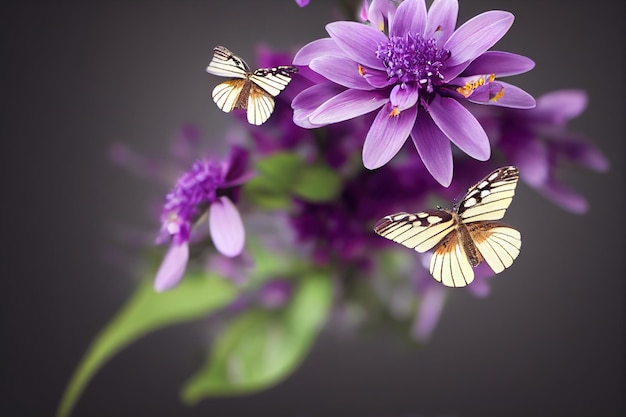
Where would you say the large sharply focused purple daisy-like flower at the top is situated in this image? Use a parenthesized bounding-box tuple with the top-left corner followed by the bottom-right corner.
(292, 0, 535, 186)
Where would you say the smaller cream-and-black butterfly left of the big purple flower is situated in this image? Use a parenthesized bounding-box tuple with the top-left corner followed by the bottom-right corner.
(206, 46, 298, 125)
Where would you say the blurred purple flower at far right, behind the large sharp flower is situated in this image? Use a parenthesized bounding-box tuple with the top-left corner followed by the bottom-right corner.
(475, 90, 609, 213)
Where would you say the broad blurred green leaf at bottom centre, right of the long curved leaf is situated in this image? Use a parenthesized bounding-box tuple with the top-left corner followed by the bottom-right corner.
(182, 272, 332, 404)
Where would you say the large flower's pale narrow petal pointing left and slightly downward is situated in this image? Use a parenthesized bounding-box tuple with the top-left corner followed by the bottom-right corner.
(309, 90, 389, 126)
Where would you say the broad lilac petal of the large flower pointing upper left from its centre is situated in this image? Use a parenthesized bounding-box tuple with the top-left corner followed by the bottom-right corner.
(326, 22, 389, 70)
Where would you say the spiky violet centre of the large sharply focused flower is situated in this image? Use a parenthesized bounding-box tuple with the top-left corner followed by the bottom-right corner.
(376, 33, 450, 93)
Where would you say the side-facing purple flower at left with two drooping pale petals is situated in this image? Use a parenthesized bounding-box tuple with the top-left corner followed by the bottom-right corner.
(154, 146, 249, 291)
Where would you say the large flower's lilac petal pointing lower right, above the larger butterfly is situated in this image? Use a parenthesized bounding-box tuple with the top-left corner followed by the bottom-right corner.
(428, 96, 491, 161)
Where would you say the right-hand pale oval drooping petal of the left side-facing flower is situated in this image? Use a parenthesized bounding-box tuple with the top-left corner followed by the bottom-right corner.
(209, 197, 246, 257)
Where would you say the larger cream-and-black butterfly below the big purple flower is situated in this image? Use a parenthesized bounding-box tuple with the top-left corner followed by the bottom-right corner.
(374, 166, 522, 287)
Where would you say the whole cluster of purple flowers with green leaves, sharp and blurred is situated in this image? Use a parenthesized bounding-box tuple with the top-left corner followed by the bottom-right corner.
(60, 0, 609, 415)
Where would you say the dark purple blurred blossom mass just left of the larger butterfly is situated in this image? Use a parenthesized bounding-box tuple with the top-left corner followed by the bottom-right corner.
(290, 161, 440, 266)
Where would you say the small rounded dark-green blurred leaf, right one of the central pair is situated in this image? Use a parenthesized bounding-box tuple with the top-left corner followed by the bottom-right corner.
(292, 165, 341, 203)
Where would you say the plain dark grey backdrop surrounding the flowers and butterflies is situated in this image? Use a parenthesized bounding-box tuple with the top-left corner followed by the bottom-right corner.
(0, 0, 626, 417)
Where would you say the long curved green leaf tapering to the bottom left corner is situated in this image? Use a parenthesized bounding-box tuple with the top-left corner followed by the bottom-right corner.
(57, 274, 237, 417)
